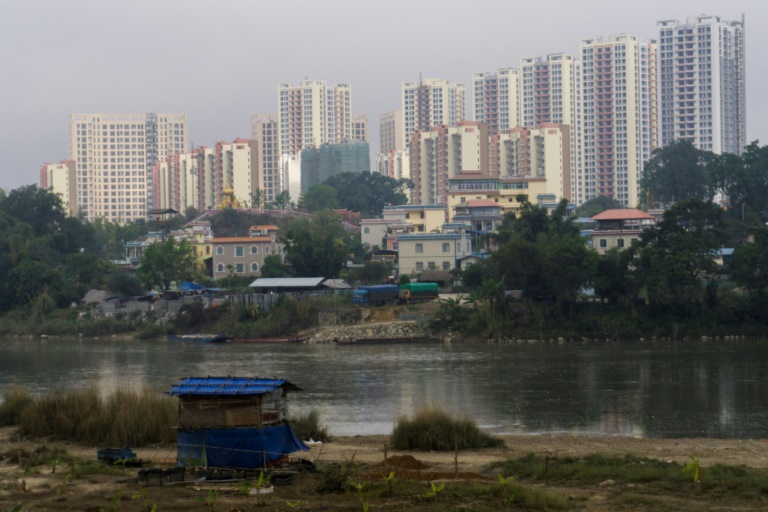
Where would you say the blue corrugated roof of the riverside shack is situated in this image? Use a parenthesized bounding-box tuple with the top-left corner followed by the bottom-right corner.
(168, 377, 301, 396)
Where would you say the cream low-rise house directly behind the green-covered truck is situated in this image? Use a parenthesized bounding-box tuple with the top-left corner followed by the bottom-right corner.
(397, 223, 472, 275)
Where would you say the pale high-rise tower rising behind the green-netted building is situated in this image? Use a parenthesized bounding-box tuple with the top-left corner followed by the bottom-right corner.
(277, 80, 352, 155)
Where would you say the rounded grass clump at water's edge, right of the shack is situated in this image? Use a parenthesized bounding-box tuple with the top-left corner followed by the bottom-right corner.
(390, 407, 504, 451)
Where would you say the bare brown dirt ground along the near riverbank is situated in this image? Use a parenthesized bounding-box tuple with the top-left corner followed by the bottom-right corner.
(0, 428, 768, 512)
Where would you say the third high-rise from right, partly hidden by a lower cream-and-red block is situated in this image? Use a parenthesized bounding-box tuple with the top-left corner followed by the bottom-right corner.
(520, 53, 583, 204)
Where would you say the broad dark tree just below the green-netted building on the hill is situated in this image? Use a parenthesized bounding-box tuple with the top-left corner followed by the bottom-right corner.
(323, 172, 413, 218)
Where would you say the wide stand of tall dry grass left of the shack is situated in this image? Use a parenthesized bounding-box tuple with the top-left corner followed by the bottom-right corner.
(19, 387, 178, 446)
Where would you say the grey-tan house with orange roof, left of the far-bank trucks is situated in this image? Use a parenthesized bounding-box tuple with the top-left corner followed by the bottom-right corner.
(211, 226, 283, 279)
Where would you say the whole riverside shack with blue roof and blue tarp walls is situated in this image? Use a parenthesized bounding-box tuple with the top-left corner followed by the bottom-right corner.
(168, 377, 308, 469)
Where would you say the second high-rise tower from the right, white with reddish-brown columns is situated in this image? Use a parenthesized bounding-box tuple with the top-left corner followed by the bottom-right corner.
(577, 34, 658, 206)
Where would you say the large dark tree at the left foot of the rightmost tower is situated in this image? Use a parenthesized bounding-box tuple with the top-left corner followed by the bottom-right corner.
(640, 139, 714, 206)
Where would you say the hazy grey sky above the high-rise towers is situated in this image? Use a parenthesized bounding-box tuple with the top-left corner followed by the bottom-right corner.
(0, 0, 768, 190)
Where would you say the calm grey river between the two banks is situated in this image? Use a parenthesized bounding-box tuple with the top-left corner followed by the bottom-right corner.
(0, 339, 768, 439)
